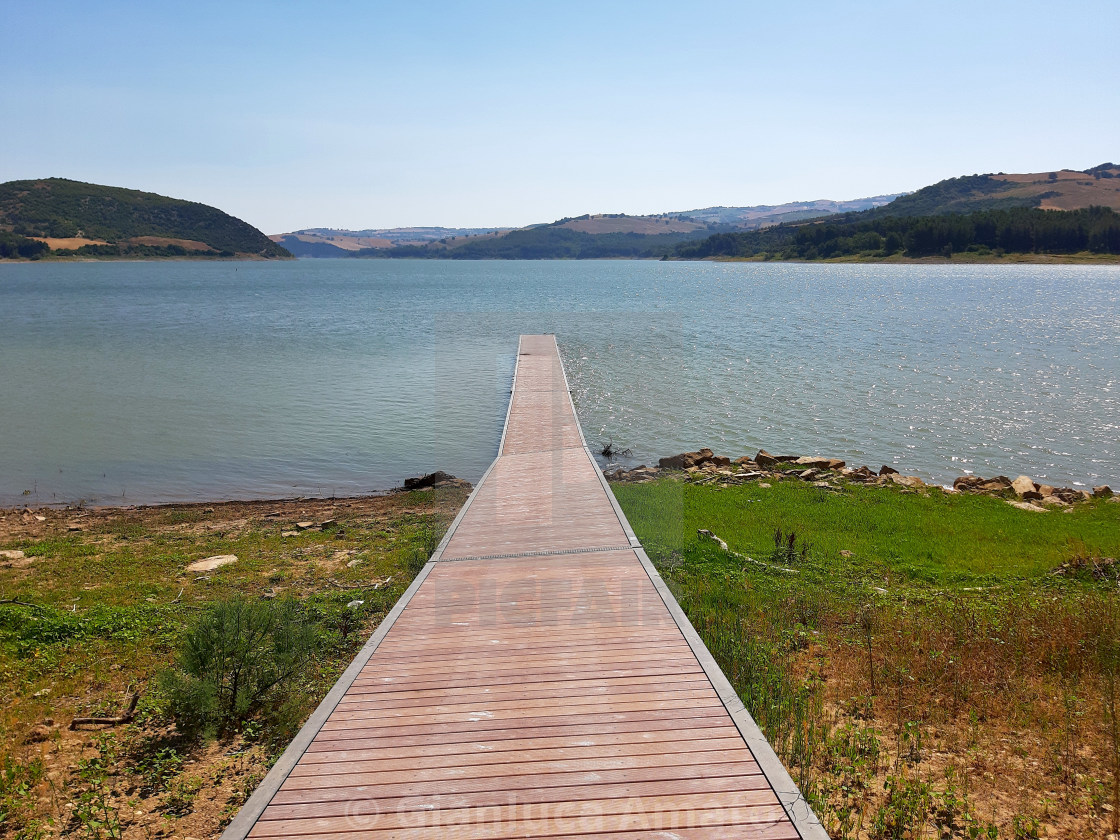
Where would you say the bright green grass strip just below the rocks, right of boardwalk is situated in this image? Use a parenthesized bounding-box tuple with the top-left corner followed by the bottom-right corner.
(615, 480, 1120, 586)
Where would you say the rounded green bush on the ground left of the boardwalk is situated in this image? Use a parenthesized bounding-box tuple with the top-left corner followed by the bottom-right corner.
(160, 597, 318, 737)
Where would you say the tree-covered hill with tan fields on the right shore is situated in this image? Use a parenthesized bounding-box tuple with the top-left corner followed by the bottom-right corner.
(674, 164, 1120, 261)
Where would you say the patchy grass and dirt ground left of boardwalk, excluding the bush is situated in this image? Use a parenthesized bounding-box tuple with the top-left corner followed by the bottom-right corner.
(0, 489, 465, 840)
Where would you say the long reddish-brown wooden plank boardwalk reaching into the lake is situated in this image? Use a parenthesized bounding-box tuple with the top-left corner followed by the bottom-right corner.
(223, 336, 827, 840)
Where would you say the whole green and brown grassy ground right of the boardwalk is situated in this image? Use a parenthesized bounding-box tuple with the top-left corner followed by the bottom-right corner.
(614, 479, 1120, 840)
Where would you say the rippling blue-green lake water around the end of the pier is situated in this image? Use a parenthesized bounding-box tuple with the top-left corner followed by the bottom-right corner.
(0, 260, 1120, 505)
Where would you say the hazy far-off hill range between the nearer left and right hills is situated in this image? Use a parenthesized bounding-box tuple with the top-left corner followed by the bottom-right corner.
(271, 195, 897, 260)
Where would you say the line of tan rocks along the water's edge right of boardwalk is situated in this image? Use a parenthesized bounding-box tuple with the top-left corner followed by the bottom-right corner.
(604, 449, 1120, 513)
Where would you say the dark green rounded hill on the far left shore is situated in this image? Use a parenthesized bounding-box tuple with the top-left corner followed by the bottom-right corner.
(0, 178, 291, 259)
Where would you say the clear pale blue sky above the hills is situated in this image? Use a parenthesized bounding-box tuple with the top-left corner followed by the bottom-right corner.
(0, 0, 1120, 233)
